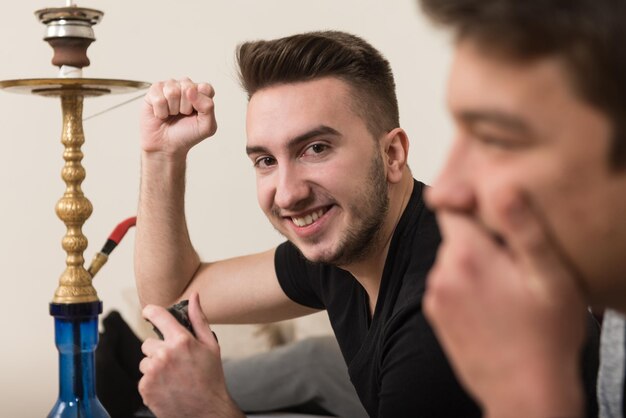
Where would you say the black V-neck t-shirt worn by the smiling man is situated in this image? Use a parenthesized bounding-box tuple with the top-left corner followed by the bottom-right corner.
(275, 181, 480, 418)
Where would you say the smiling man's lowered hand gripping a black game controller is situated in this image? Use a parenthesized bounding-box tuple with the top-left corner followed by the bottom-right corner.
(139, 293, 239, 418)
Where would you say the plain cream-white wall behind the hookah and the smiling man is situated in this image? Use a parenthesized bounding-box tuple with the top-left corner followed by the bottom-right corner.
(0, 0, 450, 417)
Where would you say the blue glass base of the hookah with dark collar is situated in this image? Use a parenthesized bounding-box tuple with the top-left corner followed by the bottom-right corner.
(48, 301, 110, 418)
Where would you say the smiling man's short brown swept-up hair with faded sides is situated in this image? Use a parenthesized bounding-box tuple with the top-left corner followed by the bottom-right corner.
(237, 31, 400, 137)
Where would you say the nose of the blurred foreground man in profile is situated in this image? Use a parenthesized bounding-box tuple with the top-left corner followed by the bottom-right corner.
(426, 139, 475, 212)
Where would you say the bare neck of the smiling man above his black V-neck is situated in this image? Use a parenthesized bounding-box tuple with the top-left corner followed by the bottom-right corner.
(341, 173, 413, 316)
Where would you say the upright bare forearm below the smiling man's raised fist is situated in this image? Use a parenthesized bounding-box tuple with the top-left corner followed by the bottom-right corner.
(135, 152, 200, 305)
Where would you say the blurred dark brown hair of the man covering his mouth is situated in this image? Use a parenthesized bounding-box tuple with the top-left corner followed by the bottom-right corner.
(421, 0, 626, 168)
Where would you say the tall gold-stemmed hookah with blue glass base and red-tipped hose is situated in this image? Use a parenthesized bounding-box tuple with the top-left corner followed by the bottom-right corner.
(0, 0, 149, 418)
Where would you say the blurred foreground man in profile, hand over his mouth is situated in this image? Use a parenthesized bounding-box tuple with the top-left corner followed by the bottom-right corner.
(421, 0, 626, 417)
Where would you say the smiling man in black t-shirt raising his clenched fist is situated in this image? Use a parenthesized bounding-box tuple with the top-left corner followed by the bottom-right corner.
(136, 32, 480, 418)
